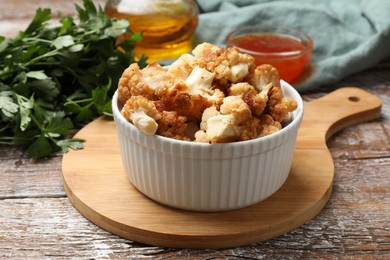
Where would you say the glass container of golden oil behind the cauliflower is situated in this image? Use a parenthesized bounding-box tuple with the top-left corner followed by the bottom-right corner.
(105, 0, 199, 62)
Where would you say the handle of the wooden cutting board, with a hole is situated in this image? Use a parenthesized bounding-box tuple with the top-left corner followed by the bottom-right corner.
(303, 87, 382, 140)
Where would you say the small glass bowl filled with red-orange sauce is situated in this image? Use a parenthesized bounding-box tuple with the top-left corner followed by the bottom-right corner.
(226, 25, 313, 83)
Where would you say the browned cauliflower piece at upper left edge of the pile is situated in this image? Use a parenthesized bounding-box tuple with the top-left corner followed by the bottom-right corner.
(118, 63, 169, 104)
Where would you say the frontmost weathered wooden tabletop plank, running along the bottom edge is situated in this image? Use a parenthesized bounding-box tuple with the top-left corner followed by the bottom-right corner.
(0, 198, 390, 259)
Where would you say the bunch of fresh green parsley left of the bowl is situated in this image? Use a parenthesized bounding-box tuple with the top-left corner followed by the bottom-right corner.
(0, 0, 146, 159)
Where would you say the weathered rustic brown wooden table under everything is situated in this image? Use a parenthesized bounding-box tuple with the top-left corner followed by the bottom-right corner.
(0, 0, 390, 259)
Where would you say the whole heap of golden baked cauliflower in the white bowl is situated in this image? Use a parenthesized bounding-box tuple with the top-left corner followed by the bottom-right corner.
(118, 43, 297, 143)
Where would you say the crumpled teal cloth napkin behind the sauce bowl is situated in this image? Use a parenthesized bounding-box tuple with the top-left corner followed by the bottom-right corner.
(196, 0, 390, 92)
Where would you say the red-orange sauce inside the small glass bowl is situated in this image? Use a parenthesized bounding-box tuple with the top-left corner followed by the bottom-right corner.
(232, 34, 311, 82)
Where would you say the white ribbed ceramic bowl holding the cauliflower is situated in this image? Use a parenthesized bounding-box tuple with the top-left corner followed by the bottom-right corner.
(112, 81, 303, 211)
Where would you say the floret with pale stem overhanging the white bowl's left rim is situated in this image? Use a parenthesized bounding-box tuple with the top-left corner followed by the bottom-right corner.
(121, 96, 161, 135)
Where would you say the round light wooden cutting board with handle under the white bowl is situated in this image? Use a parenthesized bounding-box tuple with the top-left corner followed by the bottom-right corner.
(62, 87, 382, 248)
